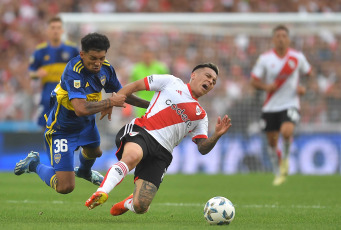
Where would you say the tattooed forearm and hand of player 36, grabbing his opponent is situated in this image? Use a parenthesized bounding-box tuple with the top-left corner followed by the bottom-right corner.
(71, 94, 126, 116)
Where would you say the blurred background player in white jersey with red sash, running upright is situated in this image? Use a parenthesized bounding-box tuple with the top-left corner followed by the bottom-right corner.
(251, 25, 311, 185)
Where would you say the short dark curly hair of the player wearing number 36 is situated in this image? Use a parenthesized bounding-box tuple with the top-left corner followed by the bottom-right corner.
(81, 33, 110, 52)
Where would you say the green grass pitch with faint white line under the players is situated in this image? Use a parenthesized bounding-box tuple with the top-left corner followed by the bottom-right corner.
(0, 173, 341, 230)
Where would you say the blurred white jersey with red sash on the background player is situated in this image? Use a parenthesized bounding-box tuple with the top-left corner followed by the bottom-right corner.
(251, 49, 311, 112)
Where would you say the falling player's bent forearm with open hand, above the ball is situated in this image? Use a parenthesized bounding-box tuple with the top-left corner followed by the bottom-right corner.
(196, 115, 232, 155)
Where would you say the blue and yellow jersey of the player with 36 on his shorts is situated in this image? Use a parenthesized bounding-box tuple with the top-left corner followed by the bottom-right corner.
(47, 55, 122, 133)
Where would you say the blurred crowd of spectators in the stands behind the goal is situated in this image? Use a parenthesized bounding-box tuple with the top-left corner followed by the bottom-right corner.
(0, 0, 341, 132)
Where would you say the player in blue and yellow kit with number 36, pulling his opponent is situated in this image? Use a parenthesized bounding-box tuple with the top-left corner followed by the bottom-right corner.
(14, 33, 149, 194)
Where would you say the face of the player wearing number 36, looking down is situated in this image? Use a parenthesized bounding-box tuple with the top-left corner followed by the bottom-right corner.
(80, 50, 107, 73)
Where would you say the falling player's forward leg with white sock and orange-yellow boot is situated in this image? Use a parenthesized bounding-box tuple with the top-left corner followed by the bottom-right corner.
(85, 142, 143, 209)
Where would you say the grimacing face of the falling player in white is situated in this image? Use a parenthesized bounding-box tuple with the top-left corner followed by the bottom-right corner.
(190, 67, 217, 98)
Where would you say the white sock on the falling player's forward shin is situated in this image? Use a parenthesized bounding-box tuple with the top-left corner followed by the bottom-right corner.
(97, 161, 129, 194)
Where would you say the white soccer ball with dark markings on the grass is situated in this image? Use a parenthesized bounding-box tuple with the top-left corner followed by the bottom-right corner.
(204, 196, 236, 225)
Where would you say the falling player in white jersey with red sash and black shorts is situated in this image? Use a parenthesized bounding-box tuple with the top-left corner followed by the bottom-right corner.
(85, 63, 231, 216)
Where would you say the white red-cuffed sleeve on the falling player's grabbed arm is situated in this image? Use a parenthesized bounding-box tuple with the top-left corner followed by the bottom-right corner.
(144, 74, 176, 92)
